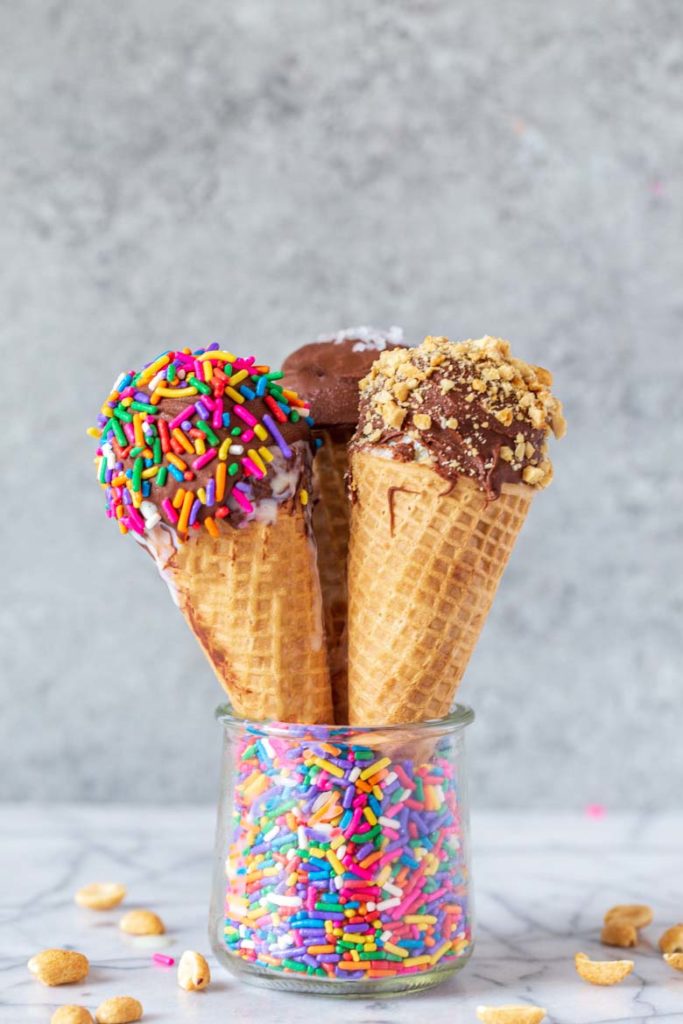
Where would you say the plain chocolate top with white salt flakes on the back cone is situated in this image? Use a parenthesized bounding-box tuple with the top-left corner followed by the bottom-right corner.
(283, 328, 403, 429)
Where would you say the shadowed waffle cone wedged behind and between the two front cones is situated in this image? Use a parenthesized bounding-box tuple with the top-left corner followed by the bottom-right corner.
(313, 430, 352, 724)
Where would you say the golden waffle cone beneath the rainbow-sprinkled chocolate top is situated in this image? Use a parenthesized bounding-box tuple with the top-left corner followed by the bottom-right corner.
(146, 506, 332, 723)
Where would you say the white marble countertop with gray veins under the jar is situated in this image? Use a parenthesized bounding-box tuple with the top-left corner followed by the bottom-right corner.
(0, 805, 683, 1024)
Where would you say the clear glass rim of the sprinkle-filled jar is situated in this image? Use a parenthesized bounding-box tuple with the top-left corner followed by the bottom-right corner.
(215, 702, 474, 737)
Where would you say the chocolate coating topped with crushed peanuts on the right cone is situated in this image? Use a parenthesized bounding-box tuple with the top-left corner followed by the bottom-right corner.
(351, 338, 564, 499)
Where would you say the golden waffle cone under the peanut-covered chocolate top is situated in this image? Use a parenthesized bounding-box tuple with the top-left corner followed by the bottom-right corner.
(348, 452, 533, 725)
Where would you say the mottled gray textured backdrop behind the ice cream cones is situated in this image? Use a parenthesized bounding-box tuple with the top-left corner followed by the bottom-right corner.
(0, 0, 683, 807)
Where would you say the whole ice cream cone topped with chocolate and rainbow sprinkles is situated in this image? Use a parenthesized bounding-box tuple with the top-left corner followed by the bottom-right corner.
(96, 346, 332, 723)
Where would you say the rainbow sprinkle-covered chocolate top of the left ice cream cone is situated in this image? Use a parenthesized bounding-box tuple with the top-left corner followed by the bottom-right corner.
(88, 344, 313, 538)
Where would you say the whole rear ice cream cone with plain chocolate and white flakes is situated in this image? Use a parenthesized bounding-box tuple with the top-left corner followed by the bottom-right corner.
(283, 327, 402, 723)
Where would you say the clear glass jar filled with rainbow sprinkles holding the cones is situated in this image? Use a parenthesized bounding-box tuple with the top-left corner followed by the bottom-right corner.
(210, 706, 474, 996)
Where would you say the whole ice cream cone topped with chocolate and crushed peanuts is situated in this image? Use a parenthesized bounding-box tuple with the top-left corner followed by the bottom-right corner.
(348, 338, 564, 725)
